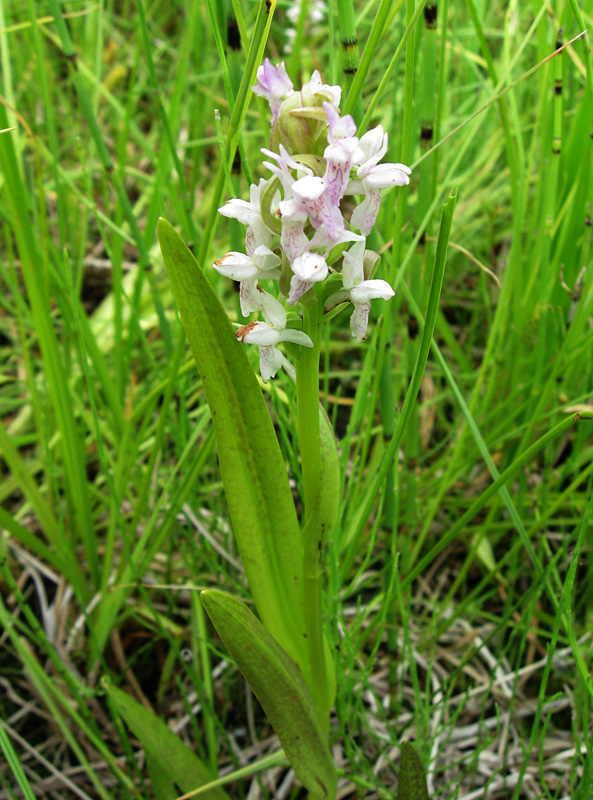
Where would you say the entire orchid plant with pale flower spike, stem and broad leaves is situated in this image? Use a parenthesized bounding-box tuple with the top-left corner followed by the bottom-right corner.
(159, 59, 411, 800)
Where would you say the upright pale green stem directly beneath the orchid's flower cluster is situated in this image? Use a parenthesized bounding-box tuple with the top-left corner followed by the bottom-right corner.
(296, 292, 329, 731)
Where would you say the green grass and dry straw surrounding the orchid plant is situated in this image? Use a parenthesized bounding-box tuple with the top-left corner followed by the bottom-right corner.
(0, 0, 593, 800)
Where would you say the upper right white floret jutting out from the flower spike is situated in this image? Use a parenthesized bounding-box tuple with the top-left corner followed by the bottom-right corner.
(346, 125, 412, 236)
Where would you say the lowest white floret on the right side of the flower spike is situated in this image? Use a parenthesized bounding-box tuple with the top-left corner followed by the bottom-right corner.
(325, 239, 395, 342)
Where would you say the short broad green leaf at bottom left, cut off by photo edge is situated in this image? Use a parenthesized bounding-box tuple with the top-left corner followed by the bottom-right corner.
(104, 681, 229, 800)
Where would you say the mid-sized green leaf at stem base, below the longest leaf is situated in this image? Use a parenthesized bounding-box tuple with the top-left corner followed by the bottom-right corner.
(201, 589, 337, 800)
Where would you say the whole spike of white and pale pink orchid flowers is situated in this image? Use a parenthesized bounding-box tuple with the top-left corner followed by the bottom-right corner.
(214, 59, 411, 382)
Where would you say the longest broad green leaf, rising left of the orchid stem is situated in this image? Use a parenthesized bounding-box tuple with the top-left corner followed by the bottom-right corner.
(158, 219, 308, 675)
